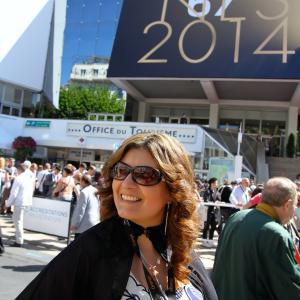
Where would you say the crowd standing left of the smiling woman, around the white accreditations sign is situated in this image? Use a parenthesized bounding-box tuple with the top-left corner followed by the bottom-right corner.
(0, 157, 101, 247)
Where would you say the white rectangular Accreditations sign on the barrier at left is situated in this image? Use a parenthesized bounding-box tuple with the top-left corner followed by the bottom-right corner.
(24, 197, 71, 237)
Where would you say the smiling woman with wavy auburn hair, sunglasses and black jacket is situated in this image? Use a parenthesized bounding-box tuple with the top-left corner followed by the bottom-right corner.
(17, 134, 217, 300)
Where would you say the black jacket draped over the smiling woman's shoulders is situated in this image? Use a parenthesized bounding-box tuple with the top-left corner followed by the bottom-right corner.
(16, 217, 217, 300)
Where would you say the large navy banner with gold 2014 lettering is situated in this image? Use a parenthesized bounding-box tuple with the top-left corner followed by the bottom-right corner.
(108, 0, 300, 79)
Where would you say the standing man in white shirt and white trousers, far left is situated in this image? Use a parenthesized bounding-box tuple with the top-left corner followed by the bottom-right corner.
(6, 164, 33, 247)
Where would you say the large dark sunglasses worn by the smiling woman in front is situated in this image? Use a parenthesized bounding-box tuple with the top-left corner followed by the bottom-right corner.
(110, 162, 163, 186)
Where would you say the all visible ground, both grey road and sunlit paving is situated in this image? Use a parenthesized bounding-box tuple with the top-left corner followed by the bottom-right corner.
(0, 215, 217, 300)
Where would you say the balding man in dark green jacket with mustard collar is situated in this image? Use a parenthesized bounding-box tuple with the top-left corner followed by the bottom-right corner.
(212, 177, 300, 300)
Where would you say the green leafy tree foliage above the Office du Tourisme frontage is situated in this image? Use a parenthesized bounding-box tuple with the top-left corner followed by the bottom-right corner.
(43, 86, 125, 120)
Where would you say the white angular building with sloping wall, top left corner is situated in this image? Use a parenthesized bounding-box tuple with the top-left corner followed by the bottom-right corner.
(0, 0, 66, 117)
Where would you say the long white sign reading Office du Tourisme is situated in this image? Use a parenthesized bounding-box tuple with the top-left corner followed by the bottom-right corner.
(67, 123, 197, 143)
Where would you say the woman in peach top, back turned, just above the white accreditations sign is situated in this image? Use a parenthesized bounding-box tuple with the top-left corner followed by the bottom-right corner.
(53, 166, 75, 201)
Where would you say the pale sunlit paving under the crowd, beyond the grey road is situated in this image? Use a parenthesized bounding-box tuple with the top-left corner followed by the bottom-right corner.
(0, 215, 217, 271)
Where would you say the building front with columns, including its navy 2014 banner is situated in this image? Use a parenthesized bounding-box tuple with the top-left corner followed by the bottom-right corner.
(109, 0, 300, 156)
